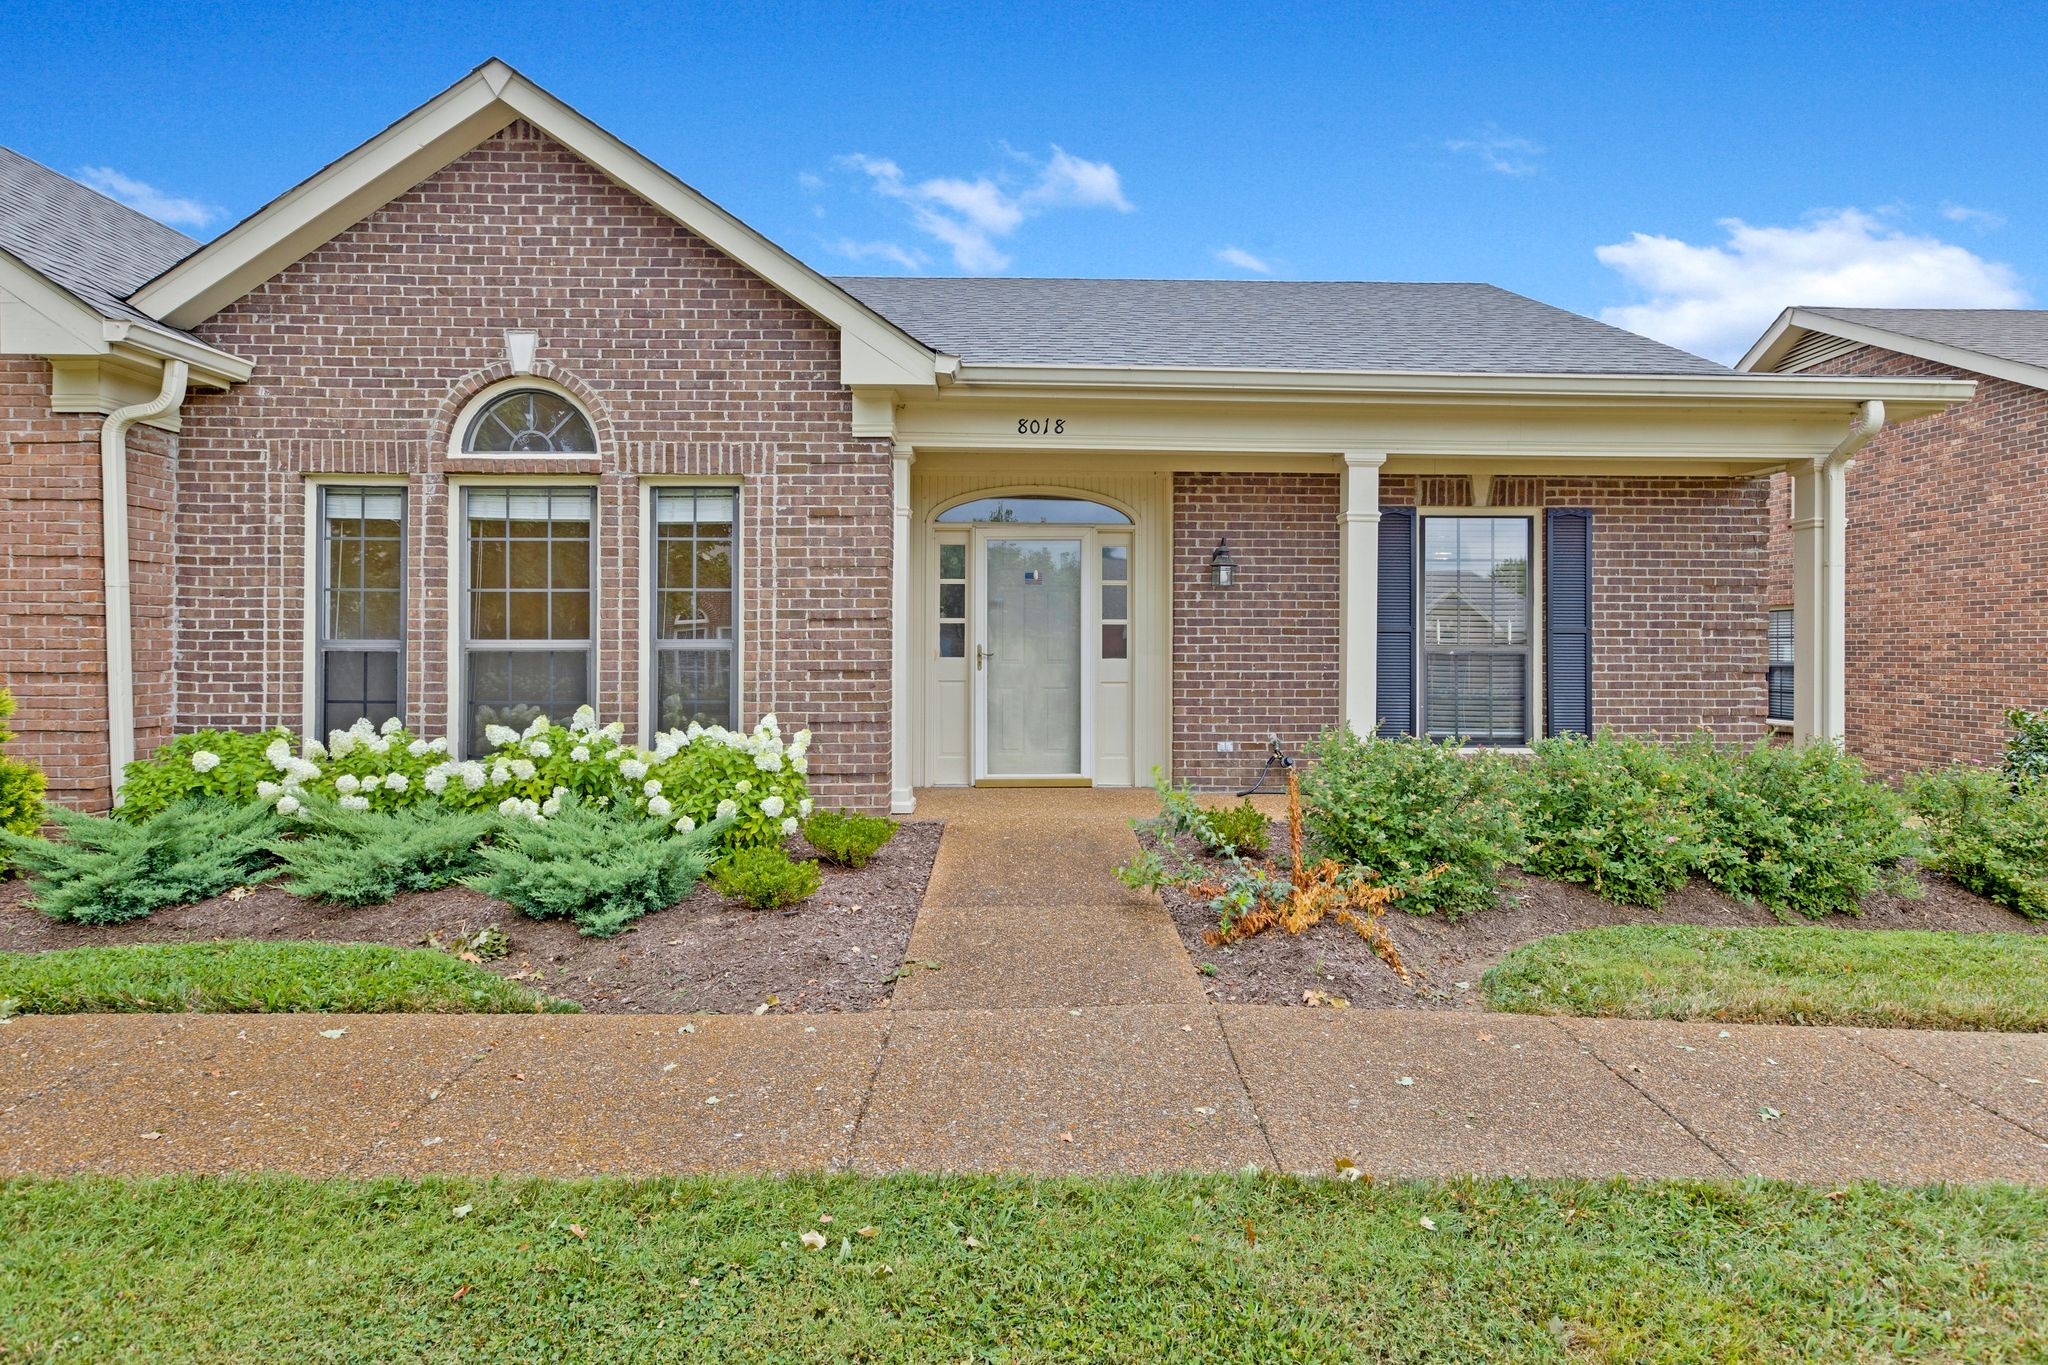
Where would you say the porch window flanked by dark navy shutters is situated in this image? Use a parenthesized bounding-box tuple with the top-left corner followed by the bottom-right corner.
(1421, 516, 1532, 745)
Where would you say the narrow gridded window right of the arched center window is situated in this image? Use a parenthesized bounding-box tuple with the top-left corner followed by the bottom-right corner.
(653, 487, 739, 731)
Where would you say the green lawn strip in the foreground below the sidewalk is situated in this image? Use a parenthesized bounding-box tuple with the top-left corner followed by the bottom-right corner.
(0, 1177, 2048, 1361)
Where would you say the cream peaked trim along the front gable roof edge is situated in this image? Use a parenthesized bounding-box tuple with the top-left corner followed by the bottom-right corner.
(129, 57, 936, 387)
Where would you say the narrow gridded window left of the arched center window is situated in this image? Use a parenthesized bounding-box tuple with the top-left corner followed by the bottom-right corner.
(313, 487, 406, 735)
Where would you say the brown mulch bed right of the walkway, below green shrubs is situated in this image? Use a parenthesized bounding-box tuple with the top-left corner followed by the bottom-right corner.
(1161, 827, 2048, 1009)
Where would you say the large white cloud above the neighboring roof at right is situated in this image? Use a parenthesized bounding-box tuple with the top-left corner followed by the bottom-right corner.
(1593, 209, 2028, 360)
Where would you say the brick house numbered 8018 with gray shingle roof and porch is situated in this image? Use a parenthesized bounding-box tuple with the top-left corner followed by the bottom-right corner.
(0, 61, 1970, 810)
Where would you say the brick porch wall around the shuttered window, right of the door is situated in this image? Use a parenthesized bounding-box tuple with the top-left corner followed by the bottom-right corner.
(1174, 473, 1769, 790)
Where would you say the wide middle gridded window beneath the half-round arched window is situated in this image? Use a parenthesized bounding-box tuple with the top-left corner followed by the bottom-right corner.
(463, 487, 596, 753)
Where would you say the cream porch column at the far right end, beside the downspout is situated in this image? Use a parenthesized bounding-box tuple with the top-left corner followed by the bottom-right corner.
(1792, 458, 1849, 743)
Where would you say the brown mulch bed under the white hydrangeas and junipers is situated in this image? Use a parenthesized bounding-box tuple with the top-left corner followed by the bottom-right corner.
(0, 821, 942, 1015)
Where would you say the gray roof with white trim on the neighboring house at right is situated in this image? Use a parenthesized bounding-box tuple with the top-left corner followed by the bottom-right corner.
(1735, 307, 2048, 389)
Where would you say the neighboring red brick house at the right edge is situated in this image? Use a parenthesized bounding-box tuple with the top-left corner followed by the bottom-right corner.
(1737, 307, 2048, 776)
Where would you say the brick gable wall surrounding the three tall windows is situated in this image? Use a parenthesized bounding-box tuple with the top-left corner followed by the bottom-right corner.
(176, 125, 891, 806)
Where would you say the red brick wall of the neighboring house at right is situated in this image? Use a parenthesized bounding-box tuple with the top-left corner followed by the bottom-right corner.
(1780, 346, 2048, 776)
